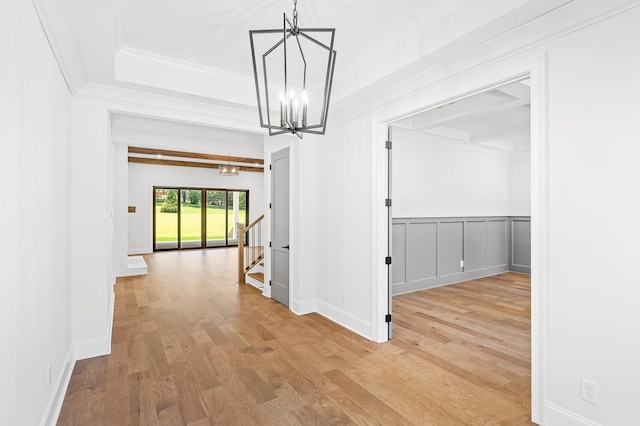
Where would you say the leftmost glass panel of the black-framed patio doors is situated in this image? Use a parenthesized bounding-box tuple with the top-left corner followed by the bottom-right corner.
(153, 188, 178, 250)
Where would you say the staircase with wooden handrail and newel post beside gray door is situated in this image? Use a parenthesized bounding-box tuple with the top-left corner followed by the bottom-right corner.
(238, 215, 264, 289)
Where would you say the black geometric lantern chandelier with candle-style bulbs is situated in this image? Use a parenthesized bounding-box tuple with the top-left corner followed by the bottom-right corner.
(249, 0, 336, 139)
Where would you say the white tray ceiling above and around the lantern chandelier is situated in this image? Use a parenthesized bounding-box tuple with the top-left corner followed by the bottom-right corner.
(40, 0, 570, 108)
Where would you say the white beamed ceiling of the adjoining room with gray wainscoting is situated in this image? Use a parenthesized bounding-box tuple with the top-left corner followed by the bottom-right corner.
(394, 80, 531, 153)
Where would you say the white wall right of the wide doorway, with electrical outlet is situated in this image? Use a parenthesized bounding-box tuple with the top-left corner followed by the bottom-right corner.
(547, 8, 640, 425)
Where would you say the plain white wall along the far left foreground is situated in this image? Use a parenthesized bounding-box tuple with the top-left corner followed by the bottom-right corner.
(0, 0, 73, 425)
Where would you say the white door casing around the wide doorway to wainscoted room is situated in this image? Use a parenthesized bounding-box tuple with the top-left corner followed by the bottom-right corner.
(372, 54, 549, 424)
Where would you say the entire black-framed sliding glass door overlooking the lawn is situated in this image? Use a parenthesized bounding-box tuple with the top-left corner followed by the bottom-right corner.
(153, 187, 249, 251)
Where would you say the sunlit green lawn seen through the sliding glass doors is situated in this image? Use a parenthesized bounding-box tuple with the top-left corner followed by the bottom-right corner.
(156, 201, 246, 242)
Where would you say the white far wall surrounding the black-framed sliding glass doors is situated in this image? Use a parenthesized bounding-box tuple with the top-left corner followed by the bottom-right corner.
(128, 163, 264, 254)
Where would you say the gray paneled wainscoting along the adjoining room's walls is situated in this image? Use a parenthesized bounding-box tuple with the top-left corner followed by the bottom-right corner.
(392, 216, 531, 294)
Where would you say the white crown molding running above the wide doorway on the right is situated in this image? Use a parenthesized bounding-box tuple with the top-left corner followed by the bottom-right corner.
(331, 0, 640, 126)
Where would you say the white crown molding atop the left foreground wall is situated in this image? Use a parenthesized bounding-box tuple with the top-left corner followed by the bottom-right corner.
(31, 0, 89, 95)
